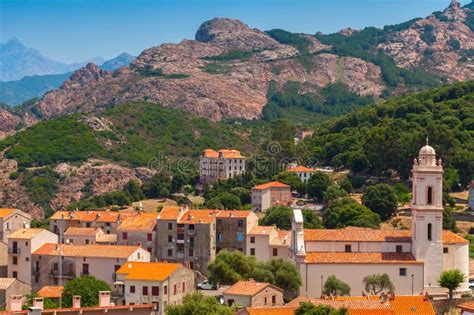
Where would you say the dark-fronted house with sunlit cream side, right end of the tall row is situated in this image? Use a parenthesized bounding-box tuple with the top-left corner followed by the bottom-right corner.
(216, 210, 258, 253)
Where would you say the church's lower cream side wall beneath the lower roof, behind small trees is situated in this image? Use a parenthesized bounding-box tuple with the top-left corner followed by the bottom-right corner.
(300, 264, 424, 297)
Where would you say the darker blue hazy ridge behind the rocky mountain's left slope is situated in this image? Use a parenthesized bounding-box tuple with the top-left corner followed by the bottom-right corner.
(0, 53, 135, 106)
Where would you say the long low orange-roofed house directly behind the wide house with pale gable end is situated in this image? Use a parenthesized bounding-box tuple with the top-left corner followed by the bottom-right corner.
(49, 210, 138, 243)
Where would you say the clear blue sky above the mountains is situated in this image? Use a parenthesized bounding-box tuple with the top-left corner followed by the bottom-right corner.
(0, 0, 470, 62)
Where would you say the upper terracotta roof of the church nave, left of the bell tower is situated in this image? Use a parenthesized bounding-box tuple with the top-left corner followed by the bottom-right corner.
(304, 227, 411, 242)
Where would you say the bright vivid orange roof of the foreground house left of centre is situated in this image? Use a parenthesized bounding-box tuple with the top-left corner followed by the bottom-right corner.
(117, 262, 184, 281)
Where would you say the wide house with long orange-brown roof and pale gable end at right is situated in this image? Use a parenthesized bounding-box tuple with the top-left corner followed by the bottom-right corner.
(29, 243, 150, 291)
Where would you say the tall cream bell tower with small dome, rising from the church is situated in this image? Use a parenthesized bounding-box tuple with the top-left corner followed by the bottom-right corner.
(412, 139, 443, 293)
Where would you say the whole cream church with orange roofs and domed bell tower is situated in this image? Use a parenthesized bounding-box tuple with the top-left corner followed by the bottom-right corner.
(291, 144, 470, 298)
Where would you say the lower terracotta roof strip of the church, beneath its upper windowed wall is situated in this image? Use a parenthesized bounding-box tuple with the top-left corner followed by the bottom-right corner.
(305, 252, 423, 264)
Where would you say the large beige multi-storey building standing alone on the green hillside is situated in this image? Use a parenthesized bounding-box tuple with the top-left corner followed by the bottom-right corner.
(199, 149, 246, 183)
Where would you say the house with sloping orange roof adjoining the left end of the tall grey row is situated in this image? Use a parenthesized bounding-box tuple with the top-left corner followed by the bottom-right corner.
(117, 213, 158, 260)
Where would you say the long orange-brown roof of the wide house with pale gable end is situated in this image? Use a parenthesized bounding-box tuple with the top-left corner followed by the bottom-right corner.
(33, 243, 140, 258)
